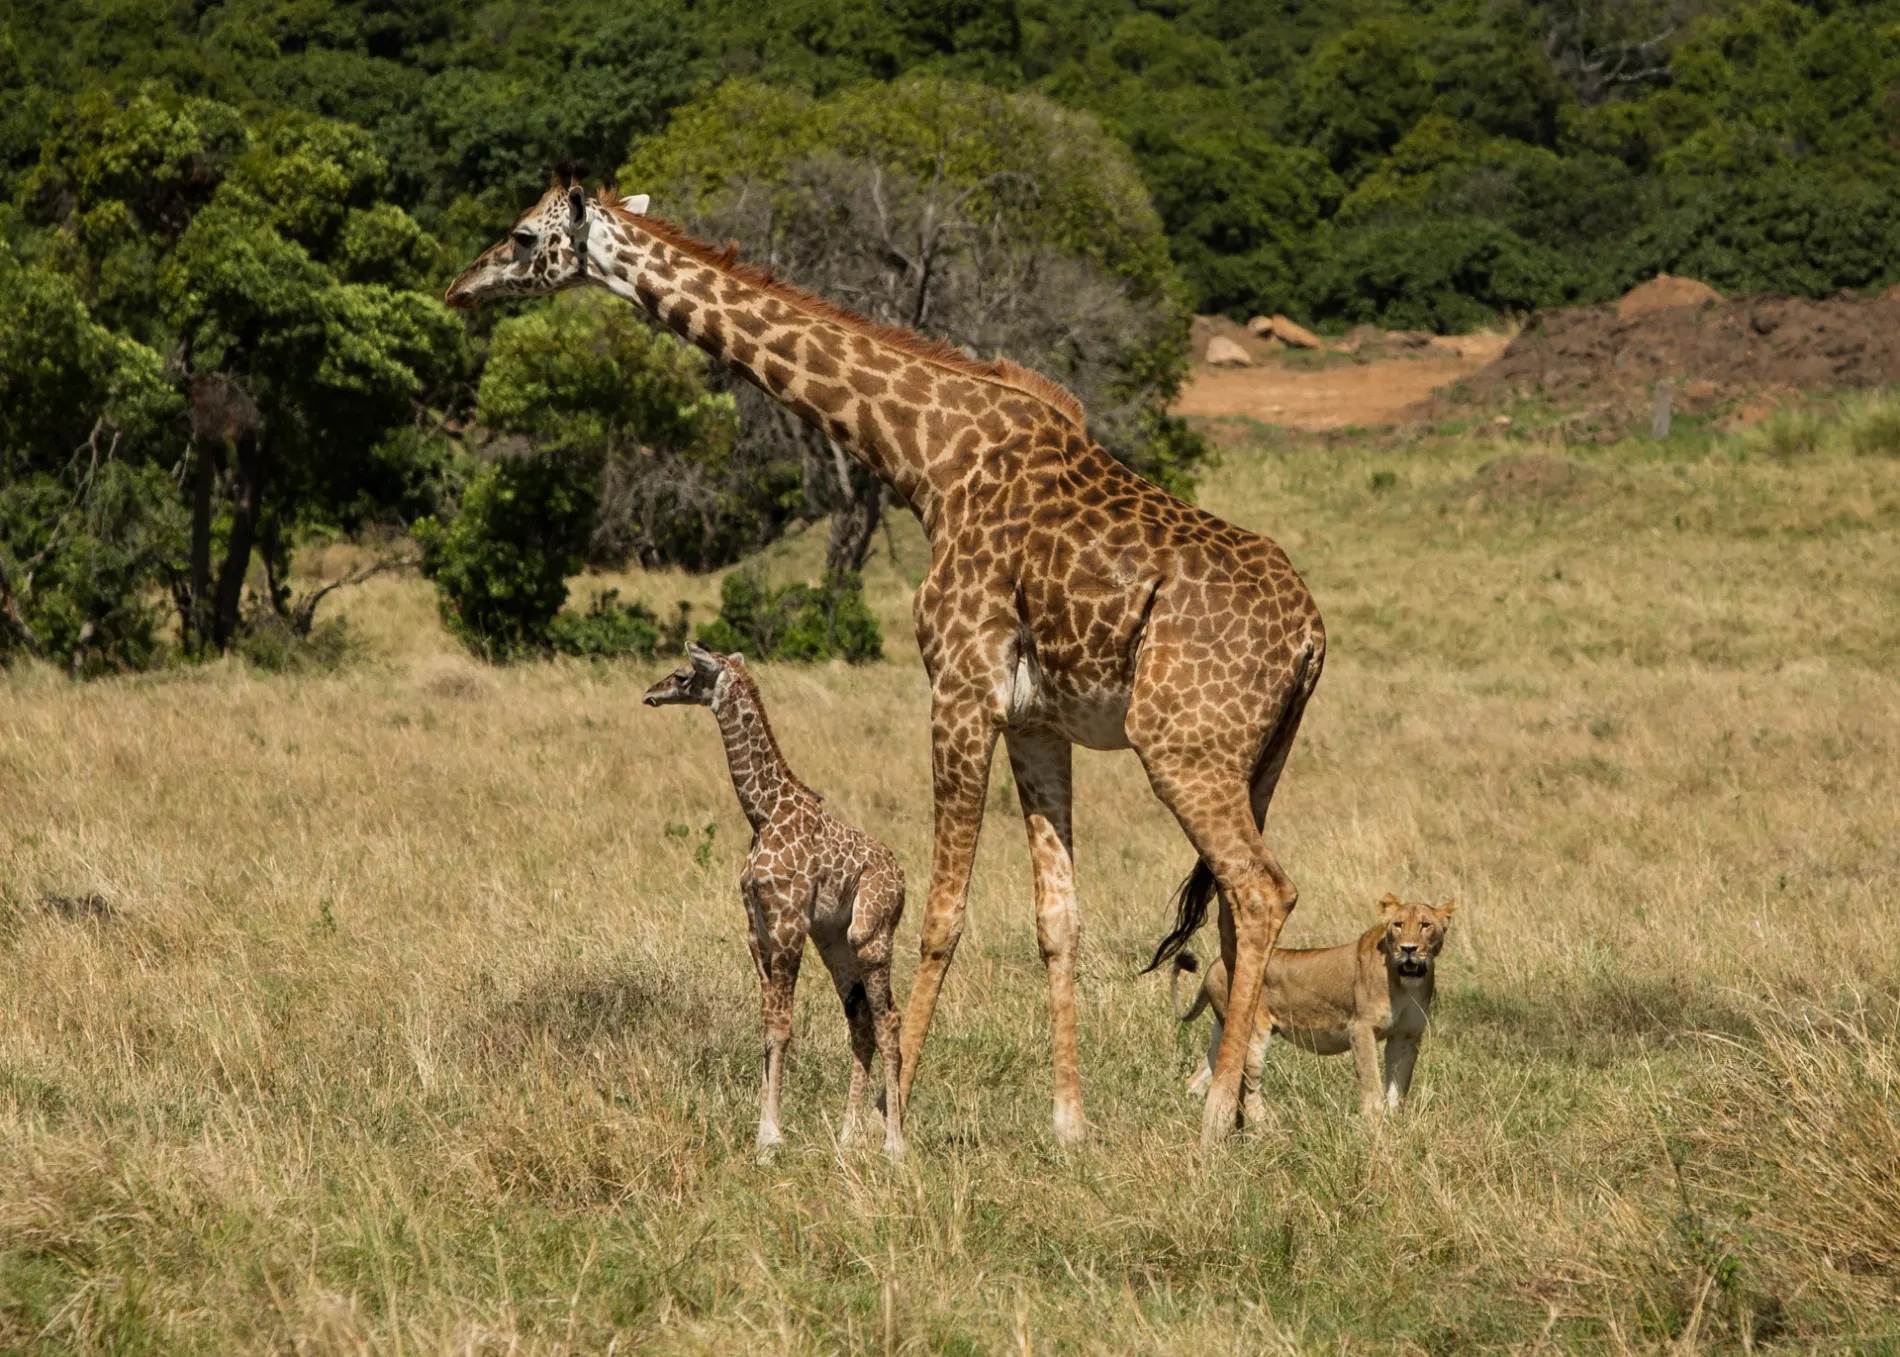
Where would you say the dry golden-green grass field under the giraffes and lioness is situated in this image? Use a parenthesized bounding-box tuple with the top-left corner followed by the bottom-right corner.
(0, 405, 1900, 1353)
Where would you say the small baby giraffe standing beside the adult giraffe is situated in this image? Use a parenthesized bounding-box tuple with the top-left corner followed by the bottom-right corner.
(646, 642, 904, 1159)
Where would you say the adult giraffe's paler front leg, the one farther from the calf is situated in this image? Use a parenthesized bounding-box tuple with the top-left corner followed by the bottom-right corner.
(1007, 730, 1089, 1144)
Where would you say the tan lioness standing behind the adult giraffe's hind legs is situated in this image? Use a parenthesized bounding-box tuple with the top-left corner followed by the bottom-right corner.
(1170, 895, 1457, 1118)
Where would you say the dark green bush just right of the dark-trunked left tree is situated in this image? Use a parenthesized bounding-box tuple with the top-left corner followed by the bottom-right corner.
(414, 454, 599, 663)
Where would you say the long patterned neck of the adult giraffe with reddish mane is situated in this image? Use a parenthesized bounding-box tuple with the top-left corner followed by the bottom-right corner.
(589, 207, 1010, 526)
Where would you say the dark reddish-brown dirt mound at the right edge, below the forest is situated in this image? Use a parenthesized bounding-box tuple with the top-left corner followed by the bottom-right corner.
(1451, 292, 1900, 437)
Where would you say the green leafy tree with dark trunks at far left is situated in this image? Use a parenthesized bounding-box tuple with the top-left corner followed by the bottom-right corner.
(29, 87, 464, 650)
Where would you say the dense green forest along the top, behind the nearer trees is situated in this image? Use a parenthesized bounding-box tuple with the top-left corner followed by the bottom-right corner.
(11, 0, 1900, 326)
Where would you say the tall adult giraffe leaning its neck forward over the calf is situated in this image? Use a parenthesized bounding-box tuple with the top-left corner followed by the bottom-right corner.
(447, 179, 1326, 1142)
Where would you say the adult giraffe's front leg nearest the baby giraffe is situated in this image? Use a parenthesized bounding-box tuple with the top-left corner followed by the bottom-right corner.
(899, 690, 996, 1112)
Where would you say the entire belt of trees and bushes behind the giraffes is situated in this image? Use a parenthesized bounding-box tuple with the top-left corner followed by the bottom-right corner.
(0, 0, 1900, 671)
